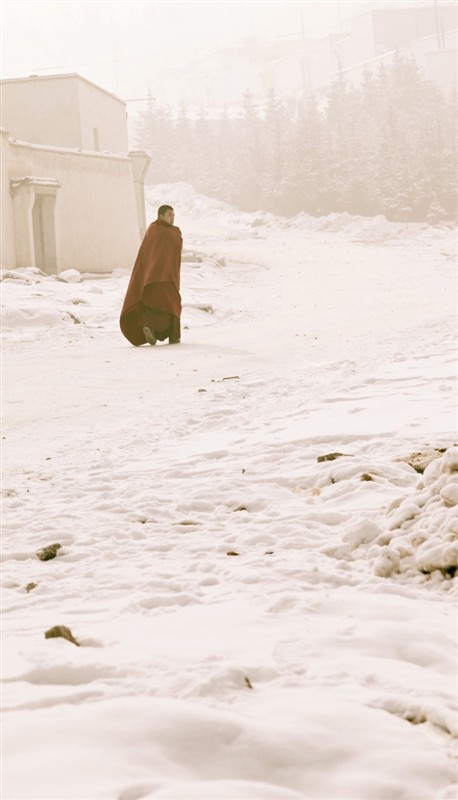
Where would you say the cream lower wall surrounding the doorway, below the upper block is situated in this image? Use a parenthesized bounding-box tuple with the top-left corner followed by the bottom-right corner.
(2, 136, 140, 272)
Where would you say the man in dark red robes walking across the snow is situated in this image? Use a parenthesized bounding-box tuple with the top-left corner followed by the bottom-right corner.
(119, 205, 183, 347)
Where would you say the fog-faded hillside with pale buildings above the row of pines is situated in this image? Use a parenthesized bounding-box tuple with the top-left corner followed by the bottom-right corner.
(153, 0, 458, 108)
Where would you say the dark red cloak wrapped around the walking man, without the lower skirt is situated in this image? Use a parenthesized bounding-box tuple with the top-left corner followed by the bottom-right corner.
(119, 219, 183, 346)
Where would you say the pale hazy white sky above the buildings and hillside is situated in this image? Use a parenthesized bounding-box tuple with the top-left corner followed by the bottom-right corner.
(1, 0, 378, 100)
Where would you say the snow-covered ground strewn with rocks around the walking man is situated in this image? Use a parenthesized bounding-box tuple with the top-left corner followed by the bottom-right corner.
(2, 185, 458, 800)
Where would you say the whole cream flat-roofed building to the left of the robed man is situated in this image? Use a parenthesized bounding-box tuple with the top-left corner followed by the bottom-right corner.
(0, 74, 150, 273)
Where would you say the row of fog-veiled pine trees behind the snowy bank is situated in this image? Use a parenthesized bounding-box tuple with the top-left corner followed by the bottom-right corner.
(137, 55, 458, 222)
